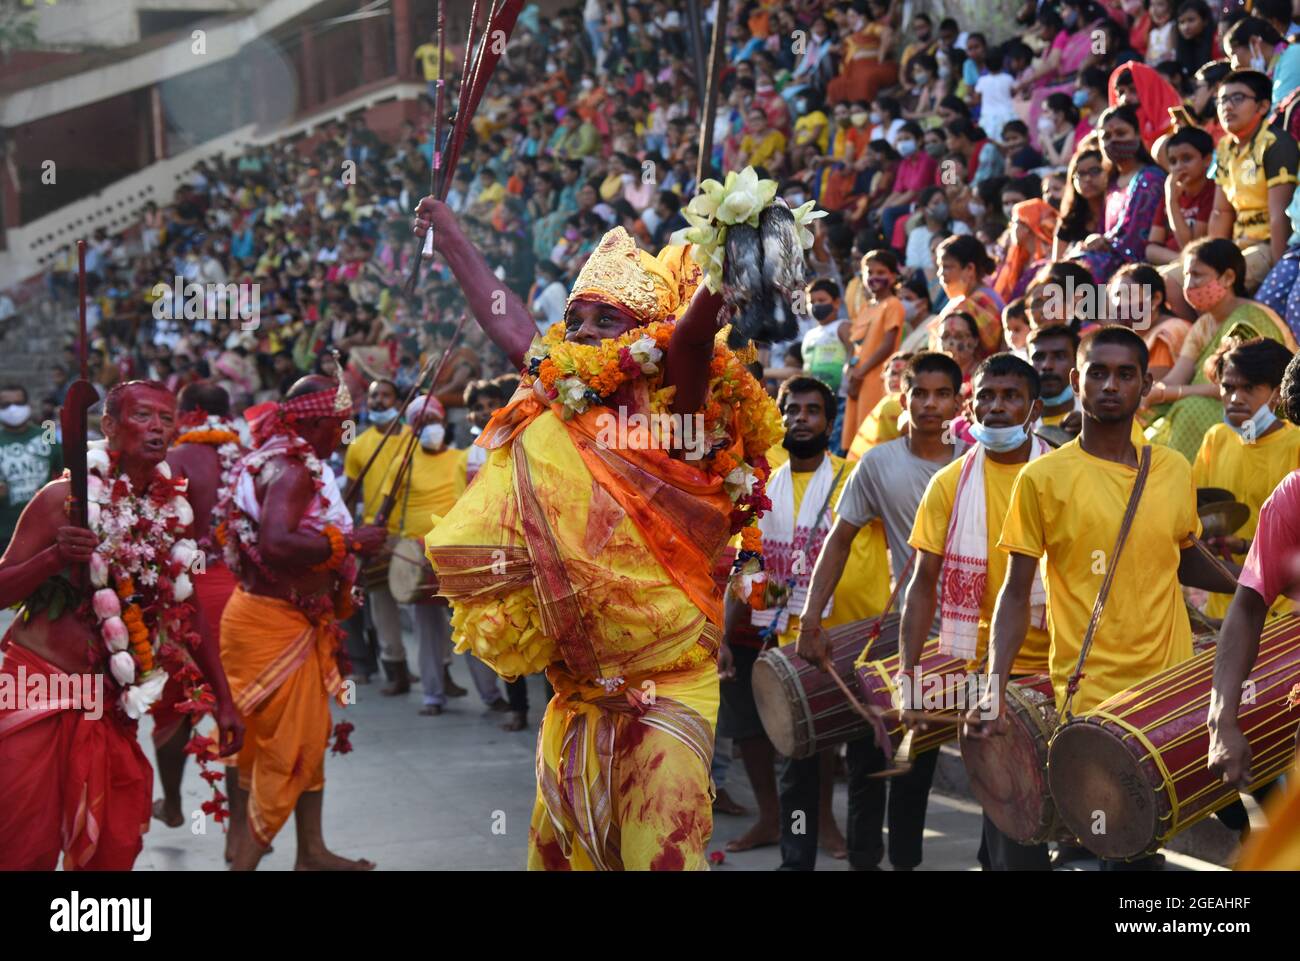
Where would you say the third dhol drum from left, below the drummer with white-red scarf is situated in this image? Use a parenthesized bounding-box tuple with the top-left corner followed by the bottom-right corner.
(961, 674, 1069, 844)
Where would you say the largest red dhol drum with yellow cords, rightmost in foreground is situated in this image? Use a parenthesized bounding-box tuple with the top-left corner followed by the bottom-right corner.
(1048, 615, 1300, 860)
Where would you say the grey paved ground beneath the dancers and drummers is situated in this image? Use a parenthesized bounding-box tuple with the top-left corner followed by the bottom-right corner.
(0, 611, 1216, 871)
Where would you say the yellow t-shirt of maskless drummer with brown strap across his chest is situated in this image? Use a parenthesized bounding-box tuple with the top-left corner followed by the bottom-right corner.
(997, 440, 1201, 714)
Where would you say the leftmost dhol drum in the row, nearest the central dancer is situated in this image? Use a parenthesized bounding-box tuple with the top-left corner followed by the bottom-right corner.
(753, 614, 898, 759)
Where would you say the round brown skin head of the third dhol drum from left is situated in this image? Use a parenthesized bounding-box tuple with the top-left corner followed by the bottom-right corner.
(961, 715, 1050, 844)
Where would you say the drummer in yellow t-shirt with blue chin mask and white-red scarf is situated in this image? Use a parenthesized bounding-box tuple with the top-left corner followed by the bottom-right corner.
(900, 354, 1050, 871)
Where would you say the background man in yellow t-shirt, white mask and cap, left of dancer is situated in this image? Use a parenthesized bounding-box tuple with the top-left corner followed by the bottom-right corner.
(384, 397, 508, 717)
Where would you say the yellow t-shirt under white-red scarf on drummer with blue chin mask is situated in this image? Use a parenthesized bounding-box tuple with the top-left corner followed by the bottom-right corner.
(907, 453, 1049, 674)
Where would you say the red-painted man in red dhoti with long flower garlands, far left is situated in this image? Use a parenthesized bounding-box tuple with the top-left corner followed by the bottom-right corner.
(0, 381, 242, 870)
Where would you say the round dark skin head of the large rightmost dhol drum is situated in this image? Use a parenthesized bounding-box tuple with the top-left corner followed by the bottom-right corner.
(1048, 722, 1158, 858)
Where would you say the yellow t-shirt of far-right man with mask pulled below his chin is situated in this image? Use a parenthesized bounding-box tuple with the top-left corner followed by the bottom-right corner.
(1192, 421, 1300, 618)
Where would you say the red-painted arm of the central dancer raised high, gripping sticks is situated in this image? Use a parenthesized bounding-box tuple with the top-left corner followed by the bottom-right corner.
(415, 196, 537, 368)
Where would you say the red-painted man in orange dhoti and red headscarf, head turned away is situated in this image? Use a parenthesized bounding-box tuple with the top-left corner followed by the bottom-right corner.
(216, 375, 387, 870)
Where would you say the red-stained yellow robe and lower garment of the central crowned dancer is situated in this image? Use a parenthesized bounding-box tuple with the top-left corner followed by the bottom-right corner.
(425, 411, 720, 870)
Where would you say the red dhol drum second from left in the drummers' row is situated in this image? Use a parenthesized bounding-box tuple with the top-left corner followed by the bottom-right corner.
(855, 637, 979, 761)
